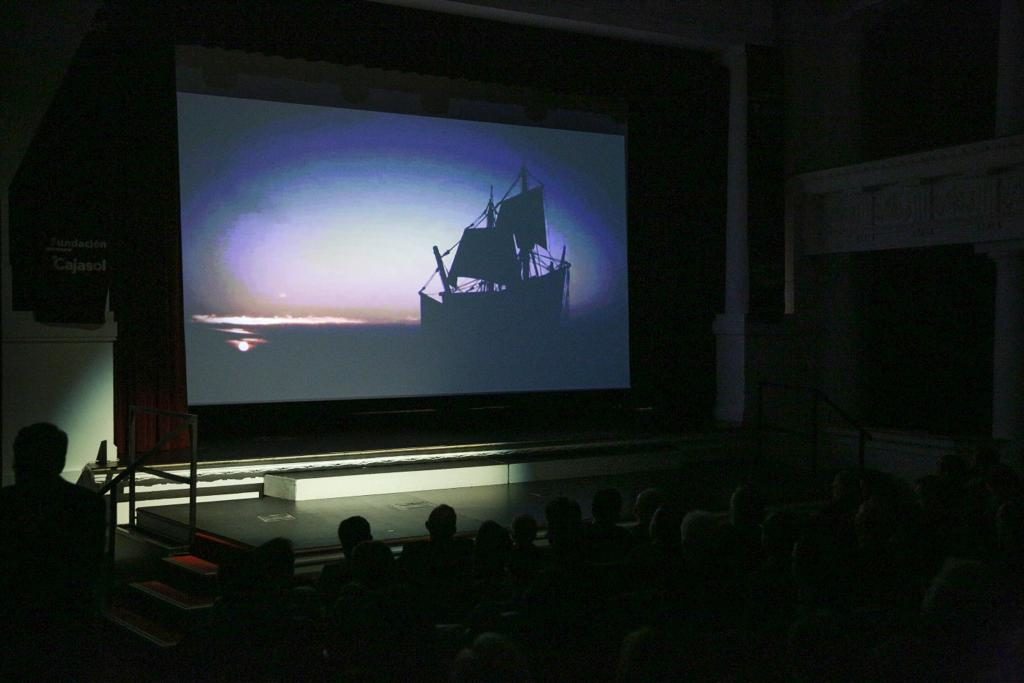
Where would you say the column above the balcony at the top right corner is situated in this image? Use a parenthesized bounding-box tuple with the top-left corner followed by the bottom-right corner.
(995, 0, 1024, 137)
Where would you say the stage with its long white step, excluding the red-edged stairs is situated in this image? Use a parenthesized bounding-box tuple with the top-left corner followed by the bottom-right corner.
(117, 434, 827, 564)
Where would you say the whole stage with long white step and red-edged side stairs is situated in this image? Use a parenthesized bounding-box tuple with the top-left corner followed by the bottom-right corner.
(99, 431, 828, 649)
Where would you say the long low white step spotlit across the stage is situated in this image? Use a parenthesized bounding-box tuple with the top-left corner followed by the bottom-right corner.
(263, 446, 684, 501)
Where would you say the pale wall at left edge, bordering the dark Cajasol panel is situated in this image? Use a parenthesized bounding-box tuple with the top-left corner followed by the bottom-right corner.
(0, 0, 117, 485)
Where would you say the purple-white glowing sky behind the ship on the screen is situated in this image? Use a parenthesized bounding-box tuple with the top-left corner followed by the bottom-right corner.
(178, 93, 626, 324)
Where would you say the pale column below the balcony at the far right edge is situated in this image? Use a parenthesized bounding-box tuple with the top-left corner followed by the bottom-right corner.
(977, 241, 1024, 465)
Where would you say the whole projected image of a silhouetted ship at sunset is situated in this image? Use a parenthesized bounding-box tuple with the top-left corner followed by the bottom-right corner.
(178, 93, 629, 405)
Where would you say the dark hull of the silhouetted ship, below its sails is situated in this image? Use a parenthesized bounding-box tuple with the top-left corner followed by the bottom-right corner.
(420, 265, 568, 335)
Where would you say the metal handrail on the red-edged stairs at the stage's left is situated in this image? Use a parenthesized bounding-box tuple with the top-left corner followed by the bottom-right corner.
(99, 405, 199, 561)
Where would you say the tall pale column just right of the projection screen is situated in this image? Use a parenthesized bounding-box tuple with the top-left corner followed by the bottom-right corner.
(713, 46, 750, 425)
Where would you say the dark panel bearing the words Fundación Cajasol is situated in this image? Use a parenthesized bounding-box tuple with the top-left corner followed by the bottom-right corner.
(8, 20, 117, 325)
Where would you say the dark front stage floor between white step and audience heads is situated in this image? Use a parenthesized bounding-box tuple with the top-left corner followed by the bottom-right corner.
(138, 460, 827, 556)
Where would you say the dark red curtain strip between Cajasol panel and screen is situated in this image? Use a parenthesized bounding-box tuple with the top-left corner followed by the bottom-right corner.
(111, 8, 188, 463)
